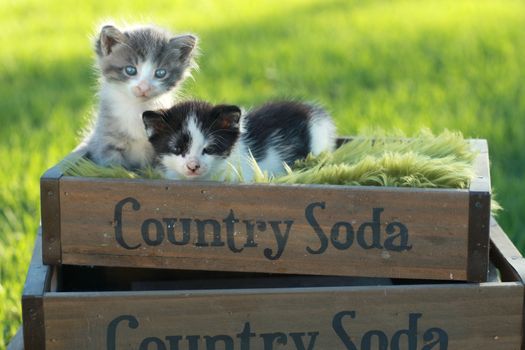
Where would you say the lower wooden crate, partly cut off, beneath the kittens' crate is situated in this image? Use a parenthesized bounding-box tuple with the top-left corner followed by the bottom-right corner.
(22, 223, 525, 350)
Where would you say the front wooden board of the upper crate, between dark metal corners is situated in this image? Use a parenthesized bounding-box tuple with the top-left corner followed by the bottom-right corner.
(60, 177, 469, 280)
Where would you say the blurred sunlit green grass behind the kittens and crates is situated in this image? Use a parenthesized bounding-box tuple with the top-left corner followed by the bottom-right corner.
(0, 0, 525, 349)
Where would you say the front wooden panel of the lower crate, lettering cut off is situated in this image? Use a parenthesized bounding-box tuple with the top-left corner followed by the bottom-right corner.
(44, 283, 523, 350)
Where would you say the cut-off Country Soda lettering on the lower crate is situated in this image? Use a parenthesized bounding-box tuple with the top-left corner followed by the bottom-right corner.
(106, 311, 449, 350)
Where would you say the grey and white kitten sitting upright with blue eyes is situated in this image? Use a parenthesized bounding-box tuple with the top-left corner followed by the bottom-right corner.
(77, 25, 197, 169)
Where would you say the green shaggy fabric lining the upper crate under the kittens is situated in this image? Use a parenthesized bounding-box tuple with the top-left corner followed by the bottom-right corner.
(63, 131, 476, 188)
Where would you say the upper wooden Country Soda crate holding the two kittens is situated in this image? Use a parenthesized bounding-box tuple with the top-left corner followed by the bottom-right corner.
(41, 140, 491, 281)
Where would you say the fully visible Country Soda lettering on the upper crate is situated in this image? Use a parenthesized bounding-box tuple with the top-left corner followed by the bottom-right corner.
(114, 197, 412, 260)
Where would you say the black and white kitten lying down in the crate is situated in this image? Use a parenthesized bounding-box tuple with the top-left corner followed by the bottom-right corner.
(143, 101, 335, 182)
